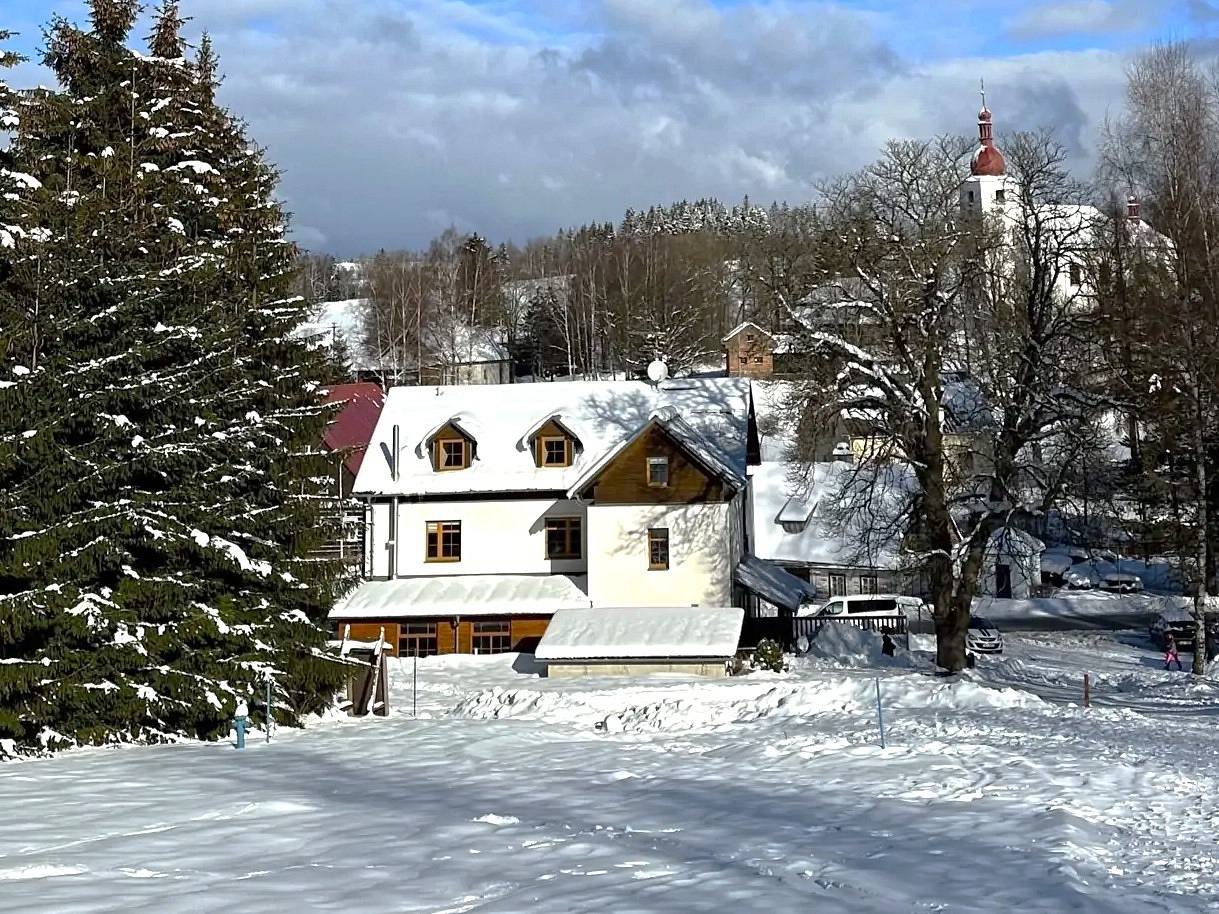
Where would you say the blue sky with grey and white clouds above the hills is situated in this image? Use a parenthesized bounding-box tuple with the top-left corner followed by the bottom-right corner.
(7, 0, 1219, 255)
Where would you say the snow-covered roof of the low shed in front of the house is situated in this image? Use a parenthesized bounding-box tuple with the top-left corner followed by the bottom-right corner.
(534, 606, 745, 662)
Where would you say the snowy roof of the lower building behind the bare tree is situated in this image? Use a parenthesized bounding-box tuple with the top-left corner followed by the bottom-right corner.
(751, 461, 914, 569)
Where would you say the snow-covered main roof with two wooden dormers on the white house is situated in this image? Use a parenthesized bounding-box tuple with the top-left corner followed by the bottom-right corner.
(355, 378, 750, 495)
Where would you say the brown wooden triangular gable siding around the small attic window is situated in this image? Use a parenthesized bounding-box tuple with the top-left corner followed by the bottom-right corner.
(592, 424, 731, 505)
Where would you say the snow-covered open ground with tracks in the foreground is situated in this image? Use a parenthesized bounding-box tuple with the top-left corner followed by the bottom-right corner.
(0, 634, 1219, 914)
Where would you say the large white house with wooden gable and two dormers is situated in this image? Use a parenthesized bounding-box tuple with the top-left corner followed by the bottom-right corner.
(332, 378, 800, 654)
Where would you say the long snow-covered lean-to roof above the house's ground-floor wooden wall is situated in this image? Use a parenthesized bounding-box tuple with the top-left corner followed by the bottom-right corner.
(330, 574, 590, 619)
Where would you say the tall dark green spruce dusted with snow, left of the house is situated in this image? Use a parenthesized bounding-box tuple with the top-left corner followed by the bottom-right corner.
(0, 0, 345, 748)
